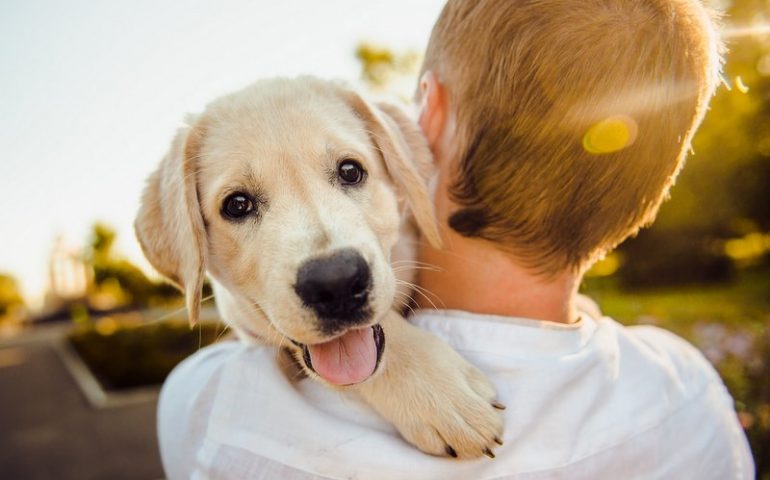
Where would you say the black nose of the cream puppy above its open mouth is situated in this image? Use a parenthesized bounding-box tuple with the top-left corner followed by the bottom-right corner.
(294, 250, 372, 327)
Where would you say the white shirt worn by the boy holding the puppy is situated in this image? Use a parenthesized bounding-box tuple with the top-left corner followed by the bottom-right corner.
(158, 311, 754, 480)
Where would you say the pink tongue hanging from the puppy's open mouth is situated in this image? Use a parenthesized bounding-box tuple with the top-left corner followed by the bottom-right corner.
(307, 328, 377, 385)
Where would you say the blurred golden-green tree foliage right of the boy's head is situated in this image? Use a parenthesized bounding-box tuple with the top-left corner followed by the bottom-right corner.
(619, 0, 770, 286)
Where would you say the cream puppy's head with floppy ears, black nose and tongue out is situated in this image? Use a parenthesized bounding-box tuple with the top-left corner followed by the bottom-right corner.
(136, 78, 439, 384)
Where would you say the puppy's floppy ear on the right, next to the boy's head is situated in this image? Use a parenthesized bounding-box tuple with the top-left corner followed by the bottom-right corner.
(343, 90, 441, 248)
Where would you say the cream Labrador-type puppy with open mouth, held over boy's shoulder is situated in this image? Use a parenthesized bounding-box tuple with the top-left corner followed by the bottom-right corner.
(135, 77, 502, 457)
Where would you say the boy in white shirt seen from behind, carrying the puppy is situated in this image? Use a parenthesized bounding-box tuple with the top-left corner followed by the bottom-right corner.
(159, 0, 753, 479)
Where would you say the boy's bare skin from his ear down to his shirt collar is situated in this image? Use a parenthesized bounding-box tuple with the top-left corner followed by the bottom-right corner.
(416, 94, 581, 323)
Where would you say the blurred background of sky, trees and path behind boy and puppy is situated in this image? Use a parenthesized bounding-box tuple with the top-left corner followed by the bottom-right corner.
(0, 0, 770, 479)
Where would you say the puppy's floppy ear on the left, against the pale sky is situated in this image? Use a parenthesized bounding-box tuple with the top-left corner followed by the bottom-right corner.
(134, 116, 206, 325)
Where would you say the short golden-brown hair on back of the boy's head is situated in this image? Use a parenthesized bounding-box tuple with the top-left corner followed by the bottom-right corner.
(423, 0, 721, 274)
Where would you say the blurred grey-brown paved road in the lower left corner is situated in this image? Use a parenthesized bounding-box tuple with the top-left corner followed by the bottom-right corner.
(0, 330, 163, 480)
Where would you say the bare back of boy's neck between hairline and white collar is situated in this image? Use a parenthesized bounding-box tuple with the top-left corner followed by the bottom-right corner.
(417, 228, 580, 323)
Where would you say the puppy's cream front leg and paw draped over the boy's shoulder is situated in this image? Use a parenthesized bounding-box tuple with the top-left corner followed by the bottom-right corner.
(354, 312, 503, 458)
